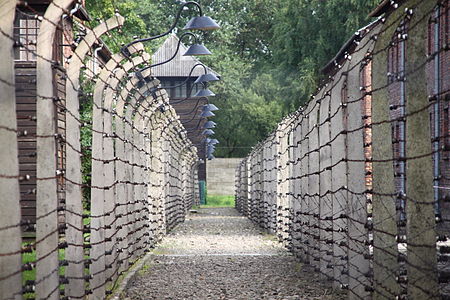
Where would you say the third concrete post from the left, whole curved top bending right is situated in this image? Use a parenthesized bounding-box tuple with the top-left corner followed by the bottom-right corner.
(66, 12, 124, 298)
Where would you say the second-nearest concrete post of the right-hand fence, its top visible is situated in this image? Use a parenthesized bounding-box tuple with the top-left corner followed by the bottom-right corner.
(372, 14, 400, 300)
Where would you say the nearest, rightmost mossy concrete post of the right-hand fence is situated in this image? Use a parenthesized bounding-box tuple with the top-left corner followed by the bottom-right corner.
(406, 1, 438, 300)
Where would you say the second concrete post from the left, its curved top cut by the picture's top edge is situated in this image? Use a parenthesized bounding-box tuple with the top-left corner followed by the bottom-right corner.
(36, 0, 74, 299)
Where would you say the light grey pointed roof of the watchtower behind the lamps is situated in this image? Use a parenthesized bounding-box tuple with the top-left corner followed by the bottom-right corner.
(152, 34, 220, 77)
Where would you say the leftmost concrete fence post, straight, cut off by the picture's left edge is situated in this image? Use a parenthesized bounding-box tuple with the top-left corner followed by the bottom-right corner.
(0, 0, 22, 300)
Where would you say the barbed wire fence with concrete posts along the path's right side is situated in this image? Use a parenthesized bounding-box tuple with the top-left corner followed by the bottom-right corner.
(236, 1, 450, 299)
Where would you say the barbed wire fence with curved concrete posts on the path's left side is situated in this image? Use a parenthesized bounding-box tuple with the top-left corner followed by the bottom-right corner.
(0, 0, 198, 299)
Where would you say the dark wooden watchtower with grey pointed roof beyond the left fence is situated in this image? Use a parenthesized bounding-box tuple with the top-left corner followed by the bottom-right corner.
(152, 34, 219, 181)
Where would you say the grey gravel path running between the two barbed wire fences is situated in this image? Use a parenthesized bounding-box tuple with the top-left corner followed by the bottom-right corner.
(127, 208, 344, 300)
